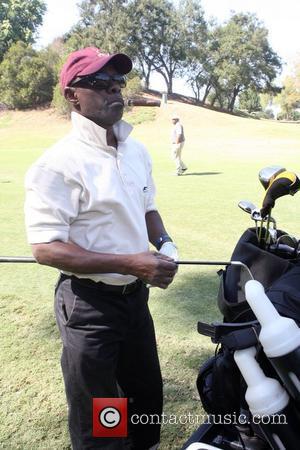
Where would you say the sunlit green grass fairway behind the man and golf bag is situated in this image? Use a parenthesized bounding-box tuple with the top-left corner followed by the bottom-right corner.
(0, 102, 300, 450)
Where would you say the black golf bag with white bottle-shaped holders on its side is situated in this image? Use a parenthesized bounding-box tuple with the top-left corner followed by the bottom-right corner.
(182, 228, 300, 450)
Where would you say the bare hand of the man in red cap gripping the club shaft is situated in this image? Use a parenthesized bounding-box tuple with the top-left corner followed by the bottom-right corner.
(130, 252, 177, 289)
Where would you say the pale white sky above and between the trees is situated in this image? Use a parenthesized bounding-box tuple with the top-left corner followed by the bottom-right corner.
(38, 0, 300, 93)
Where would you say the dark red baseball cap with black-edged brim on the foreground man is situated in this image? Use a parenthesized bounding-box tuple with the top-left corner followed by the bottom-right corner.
(60, 47, 132, 92)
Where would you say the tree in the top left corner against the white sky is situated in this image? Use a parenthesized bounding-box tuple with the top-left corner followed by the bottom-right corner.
(0, 0, 46, 62)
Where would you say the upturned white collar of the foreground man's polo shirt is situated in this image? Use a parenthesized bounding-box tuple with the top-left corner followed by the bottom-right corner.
(71, 111, 133, 148)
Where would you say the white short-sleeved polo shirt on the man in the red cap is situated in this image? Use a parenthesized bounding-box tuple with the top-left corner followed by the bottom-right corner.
(25, 112, 156, 285)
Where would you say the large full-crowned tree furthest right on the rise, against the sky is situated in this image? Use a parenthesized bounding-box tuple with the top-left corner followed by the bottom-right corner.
(200, 13, 281, 111)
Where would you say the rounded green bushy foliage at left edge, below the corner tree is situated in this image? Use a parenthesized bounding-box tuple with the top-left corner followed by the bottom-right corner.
(0, 42, 54, 109)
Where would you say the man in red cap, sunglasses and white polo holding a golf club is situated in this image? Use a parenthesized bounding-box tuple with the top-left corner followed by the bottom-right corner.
(25, 47, 177, 450)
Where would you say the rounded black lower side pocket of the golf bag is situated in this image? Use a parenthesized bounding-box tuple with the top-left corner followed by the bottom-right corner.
(197, 347, 240, 415)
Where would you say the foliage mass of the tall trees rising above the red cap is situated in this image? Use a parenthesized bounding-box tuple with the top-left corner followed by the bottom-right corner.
(66, 0, 206, 93)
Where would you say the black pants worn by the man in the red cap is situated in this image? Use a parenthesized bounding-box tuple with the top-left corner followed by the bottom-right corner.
(55, 275, 162, 450)
